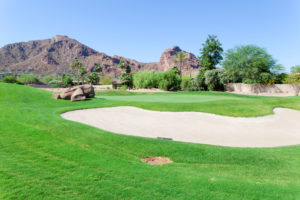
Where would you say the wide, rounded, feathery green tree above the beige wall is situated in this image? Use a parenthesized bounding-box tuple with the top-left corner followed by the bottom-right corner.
(223, 45, 276, 83)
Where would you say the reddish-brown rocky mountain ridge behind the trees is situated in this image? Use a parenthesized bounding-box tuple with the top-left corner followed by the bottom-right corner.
(0, 35, 199, 76)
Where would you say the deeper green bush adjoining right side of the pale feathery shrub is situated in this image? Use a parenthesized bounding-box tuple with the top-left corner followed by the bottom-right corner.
(158, 68, 181, 91)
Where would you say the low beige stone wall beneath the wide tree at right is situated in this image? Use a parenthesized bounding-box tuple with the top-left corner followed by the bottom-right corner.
(226, 83, 300, 96)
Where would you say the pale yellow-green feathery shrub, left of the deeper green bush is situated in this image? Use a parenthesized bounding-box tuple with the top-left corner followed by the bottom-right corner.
(133, 70, 159, 89)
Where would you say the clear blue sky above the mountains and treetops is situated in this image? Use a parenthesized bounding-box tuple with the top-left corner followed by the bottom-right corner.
(0, 0, 300, 71)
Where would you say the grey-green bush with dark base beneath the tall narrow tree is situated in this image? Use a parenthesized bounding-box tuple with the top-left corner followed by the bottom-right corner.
(204, 68, 227, 91)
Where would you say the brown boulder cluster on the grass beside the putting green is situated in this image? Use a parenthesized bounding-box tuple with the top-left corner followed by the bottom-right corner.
(52, 85, 95, 101)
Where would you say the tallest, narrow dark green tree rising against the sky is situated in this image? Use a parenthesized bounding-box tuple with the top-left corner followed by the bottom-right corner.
(199, 35, 223, 70)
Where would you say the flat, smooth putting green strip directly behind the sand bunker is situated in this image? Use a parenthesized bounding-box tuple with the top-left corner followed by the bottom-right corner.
(97, 91, 300, 117)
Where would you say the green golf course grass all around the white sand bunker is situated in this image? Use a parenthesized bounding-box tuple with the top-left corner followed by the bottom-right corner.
(0, 84, 300, 200)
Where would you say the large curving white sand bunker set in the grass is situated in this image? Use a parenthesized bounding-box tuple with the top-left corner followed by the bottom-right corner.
(62, 107, 300, 147)
